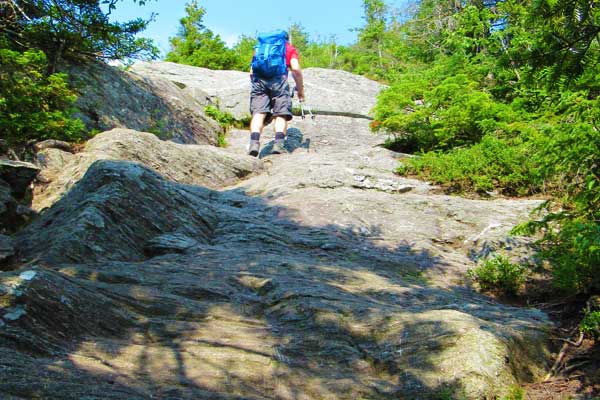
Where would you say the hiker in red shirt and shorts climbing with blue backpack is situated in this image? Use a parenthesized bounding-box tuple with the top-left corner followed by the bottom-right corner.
(248, 30, 304, 157)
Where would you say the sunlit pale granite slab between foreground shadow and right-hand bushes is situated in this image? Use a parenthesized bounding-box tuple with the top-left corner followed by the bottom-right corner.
(228, 116, 541, 281)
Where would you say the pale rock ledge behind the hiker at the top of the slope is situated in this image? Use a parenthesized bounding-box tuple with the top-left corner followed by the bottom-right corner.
(132, 61, 384, 119)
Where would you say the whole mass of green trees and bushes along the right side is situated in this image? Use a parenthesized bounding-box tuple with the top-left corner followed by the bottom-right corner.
(364, 0, 600, 293)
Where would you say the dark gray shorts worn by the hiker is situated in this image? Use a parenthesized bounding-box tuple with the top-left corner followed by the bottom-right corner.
(250, 76, 292, 125)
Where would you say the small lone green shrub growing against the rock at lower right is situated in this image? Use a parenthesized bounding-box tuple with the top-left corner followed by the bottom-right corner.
(467, 255, 527, 294)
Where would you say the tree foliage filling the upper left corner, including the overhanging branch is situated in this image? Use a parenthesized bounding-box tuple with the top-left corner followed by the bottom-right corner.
(0, 0, 158, 147)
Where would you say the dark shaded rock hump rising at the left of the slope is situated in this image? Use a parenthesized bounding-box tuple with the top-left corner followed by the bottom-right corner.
(17, 160, 216, 263)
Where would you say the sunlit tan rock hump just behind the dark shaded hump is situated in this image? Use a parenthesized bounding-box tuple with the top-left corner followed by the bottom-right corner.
(33, 129, 262, 210)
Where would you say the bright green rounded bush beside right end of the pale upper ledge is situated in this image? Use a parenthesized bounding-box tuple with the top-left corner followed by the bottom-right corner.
(372, 57, 525, 153)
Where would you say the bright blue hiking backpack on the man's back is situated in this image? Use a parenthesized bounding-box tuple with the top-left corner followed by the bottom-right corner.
(252, 30, 288, 79)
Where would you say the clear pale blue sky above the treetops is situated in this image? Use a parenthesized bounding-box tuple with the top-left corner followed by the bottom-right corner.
(106, 0, 405, 55)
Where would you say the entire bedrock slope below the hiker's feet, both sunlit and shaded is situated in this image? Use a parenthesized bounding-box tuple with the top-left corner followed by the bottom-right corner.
(0, 63, 549, 399)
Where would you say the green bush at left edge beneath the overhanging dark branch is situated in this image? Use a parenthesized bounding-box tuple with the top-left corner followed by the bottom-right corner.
(0, 48, 84, 146)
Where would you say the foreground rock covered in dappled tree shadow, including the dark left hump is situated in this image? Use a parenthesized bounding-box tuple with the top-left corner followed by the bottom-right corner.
(0, 161, 548, 400)
